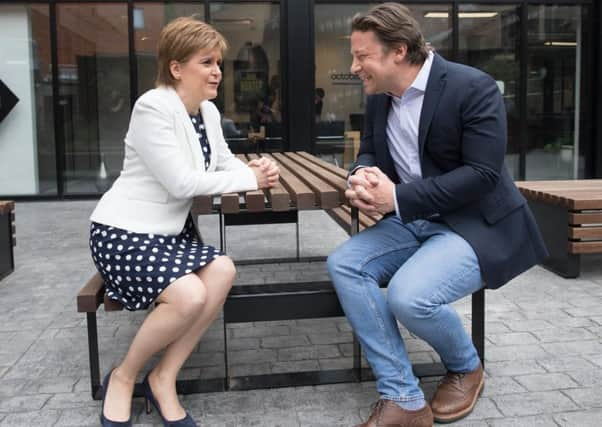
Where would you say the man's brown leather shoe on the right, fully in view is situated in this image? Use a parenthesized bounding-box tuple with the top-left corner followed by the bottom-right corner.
(431, 364, 485, 423)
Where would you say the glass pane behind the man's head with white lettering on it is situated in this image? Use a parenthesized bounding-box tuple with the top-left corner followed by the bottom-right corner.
(314, 3, 451, 167)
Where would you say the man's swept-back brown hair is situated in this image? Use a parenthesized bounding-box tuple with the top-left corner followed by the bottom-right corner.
(351, 3, 429, 64)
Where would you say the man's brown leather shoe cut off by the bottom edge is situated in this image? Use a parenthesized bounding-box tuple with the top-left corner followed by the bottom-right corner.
(355, 399, 433, 427)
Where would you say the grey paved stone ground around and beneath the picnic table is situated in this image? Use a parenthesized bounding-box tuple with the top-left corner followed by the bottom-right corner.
(0, 202, 602, 427)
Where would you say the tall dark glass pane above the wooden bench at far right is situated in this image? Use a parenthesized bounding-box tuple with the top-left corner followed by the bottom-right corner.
(526, 5, 585, 179)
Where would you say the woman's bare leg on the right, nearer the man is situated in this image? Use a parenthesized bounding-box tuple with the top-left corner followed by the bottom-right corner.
(149, 256, 236, 420)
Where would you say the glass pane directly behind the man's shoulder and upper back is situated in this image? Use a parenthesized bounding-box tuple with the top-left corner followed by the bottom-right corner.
(458, 5, 521, 178)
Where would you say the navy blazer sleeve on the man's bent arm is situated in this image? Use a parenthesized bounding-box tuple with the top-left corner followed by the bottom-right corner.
(396, 74, 506, 221)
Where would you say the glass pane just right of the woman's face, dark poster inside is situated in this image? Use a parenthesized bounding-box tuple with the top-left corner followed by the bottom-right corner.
(210, 2, 283, 153)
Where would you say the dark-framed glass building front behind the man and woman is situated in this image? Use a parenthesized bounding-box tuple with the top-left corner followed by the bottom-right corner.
(0, 0, 602, 199)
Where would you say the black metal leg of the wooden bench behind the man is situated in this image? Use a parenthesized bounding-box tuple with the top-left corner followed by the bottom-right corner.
(529, 200, 581, 278)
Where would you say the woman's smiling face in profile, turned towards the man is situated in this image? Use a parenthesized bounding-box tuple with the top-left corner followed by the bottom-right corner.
(172, 48, 222, 103)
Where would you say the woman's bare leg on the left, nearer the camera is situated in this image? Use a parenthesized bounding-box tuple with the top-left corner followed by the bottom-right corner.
(104, 274, 208, 421)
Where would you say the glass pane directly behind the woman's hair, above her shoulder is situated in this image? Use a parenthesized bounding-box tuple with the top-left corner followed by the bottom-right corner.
(134, 3, 205, 96)
